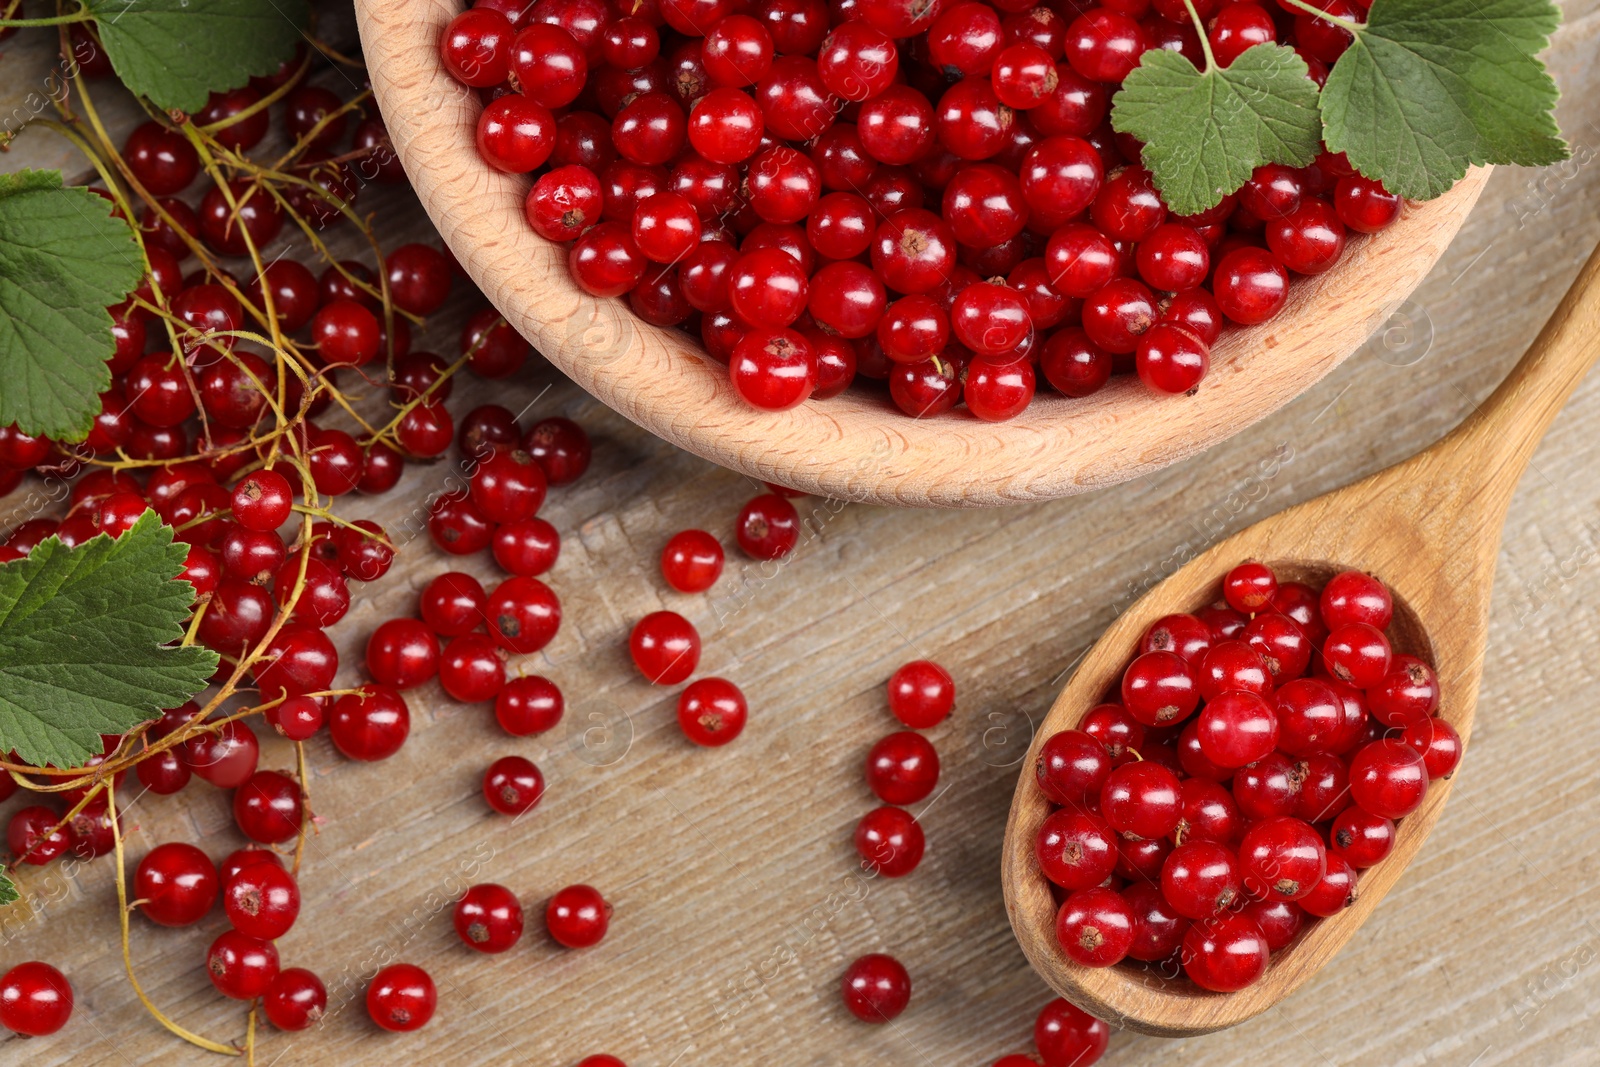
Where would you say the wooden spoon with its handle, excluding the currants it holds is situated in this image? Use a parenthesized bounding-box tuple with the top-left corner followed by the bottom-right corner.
(1002, 239, 1600, 1037)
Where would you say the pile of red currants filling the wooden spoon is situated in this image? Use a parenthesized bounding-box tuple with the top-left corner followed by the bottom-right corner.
(1035, 561, 1462, 992)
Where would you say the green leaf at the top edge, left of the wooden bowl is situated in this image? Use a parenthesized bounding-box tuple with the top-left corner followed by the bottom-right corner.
(85, 0, 309, 112)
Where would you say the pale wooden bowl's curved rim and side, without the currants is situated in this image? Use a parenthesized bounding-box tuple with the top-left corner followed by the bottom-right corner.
(355, 0, 1488, 507)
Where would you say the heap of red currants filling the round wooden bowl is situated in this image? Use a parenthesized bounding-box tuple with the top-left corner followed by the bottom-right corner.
(440, 0, 1402, 419)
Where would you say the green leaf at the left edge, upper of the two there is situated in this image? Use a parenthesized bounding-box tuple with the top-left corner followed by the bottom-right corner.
(0, 171, 144, 440)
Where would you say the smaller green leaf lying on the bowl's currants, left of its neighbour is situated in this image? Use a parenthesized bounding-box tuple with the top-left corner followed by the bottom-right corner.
(1110, 45, 1322, 214)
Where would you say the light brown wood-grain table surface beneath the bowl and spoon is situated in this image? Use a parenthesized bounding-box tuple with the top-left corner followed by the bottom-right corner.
(0, 0, 1600, 1067)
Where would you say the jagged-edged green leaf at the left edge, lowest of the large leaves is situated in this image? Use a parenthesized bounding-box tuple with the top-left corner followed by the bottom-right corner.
(0, 512, 218, 766)
